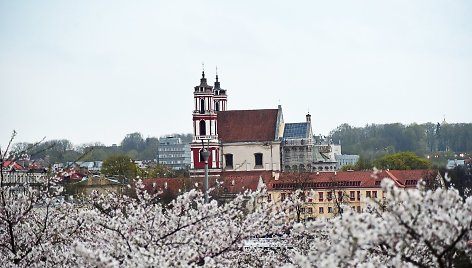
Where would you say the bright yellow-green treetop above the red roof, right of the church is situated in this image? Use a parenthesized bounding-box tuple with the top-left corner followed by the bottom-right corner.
(374, 152, 431, 170)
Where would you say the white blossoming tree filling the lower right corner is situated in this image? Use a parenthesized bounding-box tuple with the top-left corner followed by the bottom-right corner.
(291, 180, 472, 267)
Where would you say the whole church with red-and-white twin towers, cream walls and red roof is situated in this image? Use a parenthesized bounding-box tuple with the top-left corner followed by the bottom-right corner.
(190, 71, 285, 175)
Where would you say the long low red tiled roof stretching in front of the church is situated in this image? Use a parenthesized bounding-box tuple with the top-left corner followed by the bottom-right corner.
(136, 170, 435, 198)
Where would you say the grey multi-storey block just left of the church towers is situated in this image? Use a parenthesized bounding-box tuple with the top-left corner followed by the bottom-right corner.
(157, 136, 190, 170)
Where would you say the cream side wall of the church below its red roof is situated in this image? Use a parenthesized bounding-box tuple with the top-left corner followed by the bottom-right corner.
(221, 142, 280, 171)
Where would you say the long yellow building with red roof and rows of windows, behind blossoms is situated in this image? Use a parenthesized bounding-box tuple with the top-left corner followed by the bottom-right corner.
(265, 170, 438, 220)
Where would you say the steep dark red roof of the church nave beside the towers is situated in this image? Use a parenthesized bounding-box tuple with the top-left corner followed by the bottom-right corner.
(218, 109, 278, 142)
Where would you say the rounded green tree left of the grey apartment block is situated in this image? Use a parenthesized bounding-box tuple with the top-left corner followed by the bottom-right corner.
(101, 154, 137, 179)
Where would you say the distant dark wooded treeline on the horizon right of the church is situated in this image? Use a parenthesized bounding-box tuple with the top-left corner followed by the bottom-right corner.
(330, 123, 472, 159)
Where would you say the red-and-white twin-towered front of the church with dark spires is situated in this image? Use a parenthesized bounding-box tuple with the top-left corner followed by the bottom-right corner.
(190, 71, 223, 172)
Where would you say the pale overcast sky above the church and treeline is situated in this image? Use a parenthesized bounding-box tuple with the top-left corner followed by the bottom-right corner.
(0, 0, 472, 147)
